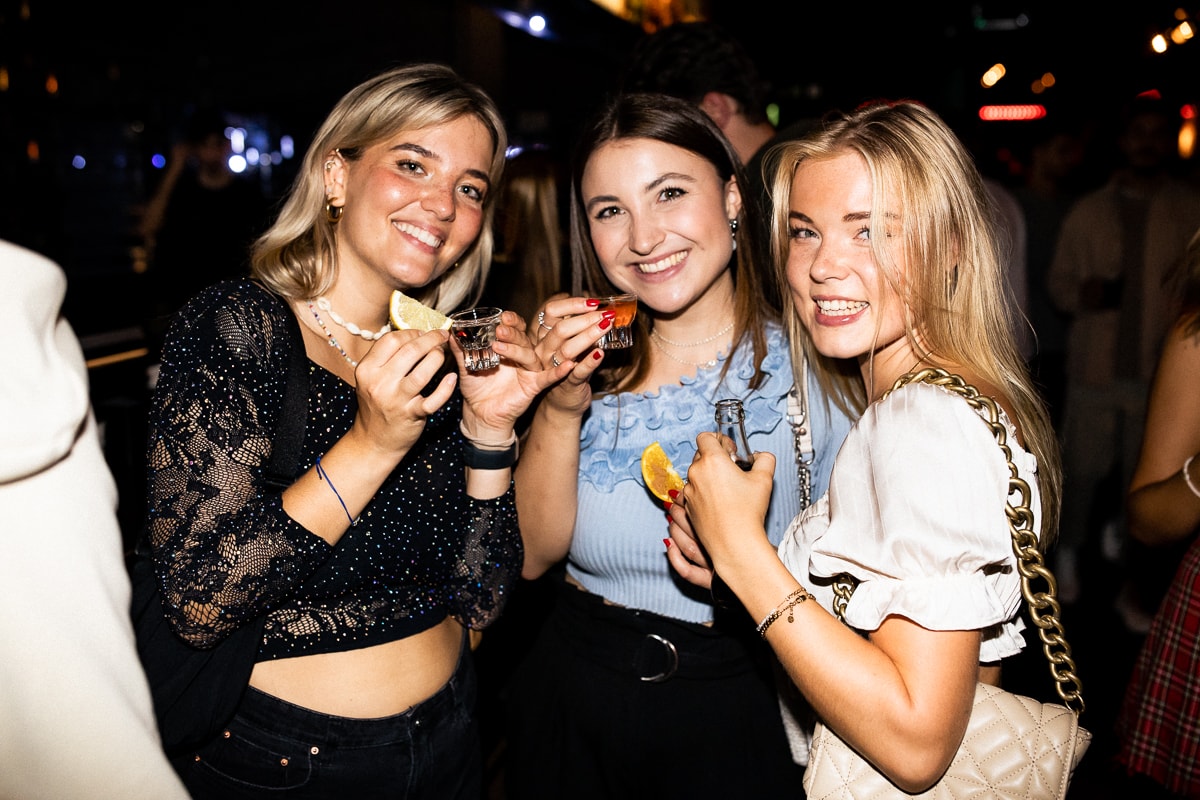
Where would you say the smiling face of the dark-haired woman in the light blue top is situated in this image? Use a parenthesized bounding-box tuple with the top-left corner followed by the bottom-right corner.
(581, 138, 742, 314)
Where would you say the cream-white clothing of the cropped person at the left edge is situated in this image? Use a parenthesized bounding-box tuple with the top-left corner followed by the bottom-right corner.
(0, 241, 187, 800)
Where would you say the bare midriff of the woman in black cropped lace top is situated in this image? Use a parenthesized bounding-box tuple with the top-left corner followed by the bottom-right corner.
(250, 618, 463, 720)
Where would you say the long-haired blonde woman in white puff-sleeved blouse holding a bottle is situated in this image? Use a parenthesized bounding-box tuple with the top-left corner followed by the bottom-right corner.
(671, 102, 1060, 793)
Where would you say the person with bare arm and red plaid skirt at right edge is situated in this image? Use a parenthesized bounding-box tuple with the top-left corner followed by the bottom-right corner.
(1116, 225, 1200, 798)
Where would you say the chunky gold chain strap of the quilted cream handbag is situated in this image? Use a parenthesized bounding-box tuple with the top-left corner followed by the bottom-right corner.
(833, 369, 1085, 714)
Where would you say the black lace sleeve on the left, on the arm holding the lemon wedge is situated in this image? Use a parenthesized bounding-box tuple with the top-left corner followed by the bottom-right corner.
(148, 284, 330, 646)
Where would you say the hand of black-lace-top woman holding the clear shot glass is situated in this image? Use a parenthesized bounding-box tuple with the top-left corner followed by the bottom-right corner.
(450, 311, 571, 440)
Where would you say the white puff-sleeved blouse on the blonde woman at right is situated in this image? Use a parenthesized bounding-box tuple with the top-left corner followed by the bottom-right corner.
(779, 384, 1040, 662)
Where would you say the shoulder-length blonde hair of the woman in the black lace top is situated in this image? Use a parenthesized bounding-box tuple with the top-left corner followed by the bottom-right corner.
(251, 64, 508, 313)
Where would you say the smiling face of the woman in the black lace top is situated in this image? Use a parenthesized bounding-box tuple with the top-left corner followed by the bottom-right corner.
(325, 115, 494, 291)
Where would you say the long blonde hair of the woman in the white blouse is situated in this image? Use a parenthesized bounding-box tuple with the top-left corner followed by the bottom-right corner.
(770, 102, 1062, 549)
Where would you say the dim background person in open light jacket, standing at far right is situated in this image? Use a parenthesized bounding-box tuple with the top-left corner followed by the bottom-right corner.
(1049, 95, 1200, 618)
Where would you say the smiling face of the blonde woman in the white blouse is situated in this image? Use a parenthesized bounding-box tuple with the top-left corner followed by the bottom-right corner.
(787, 151, 916, 396)
